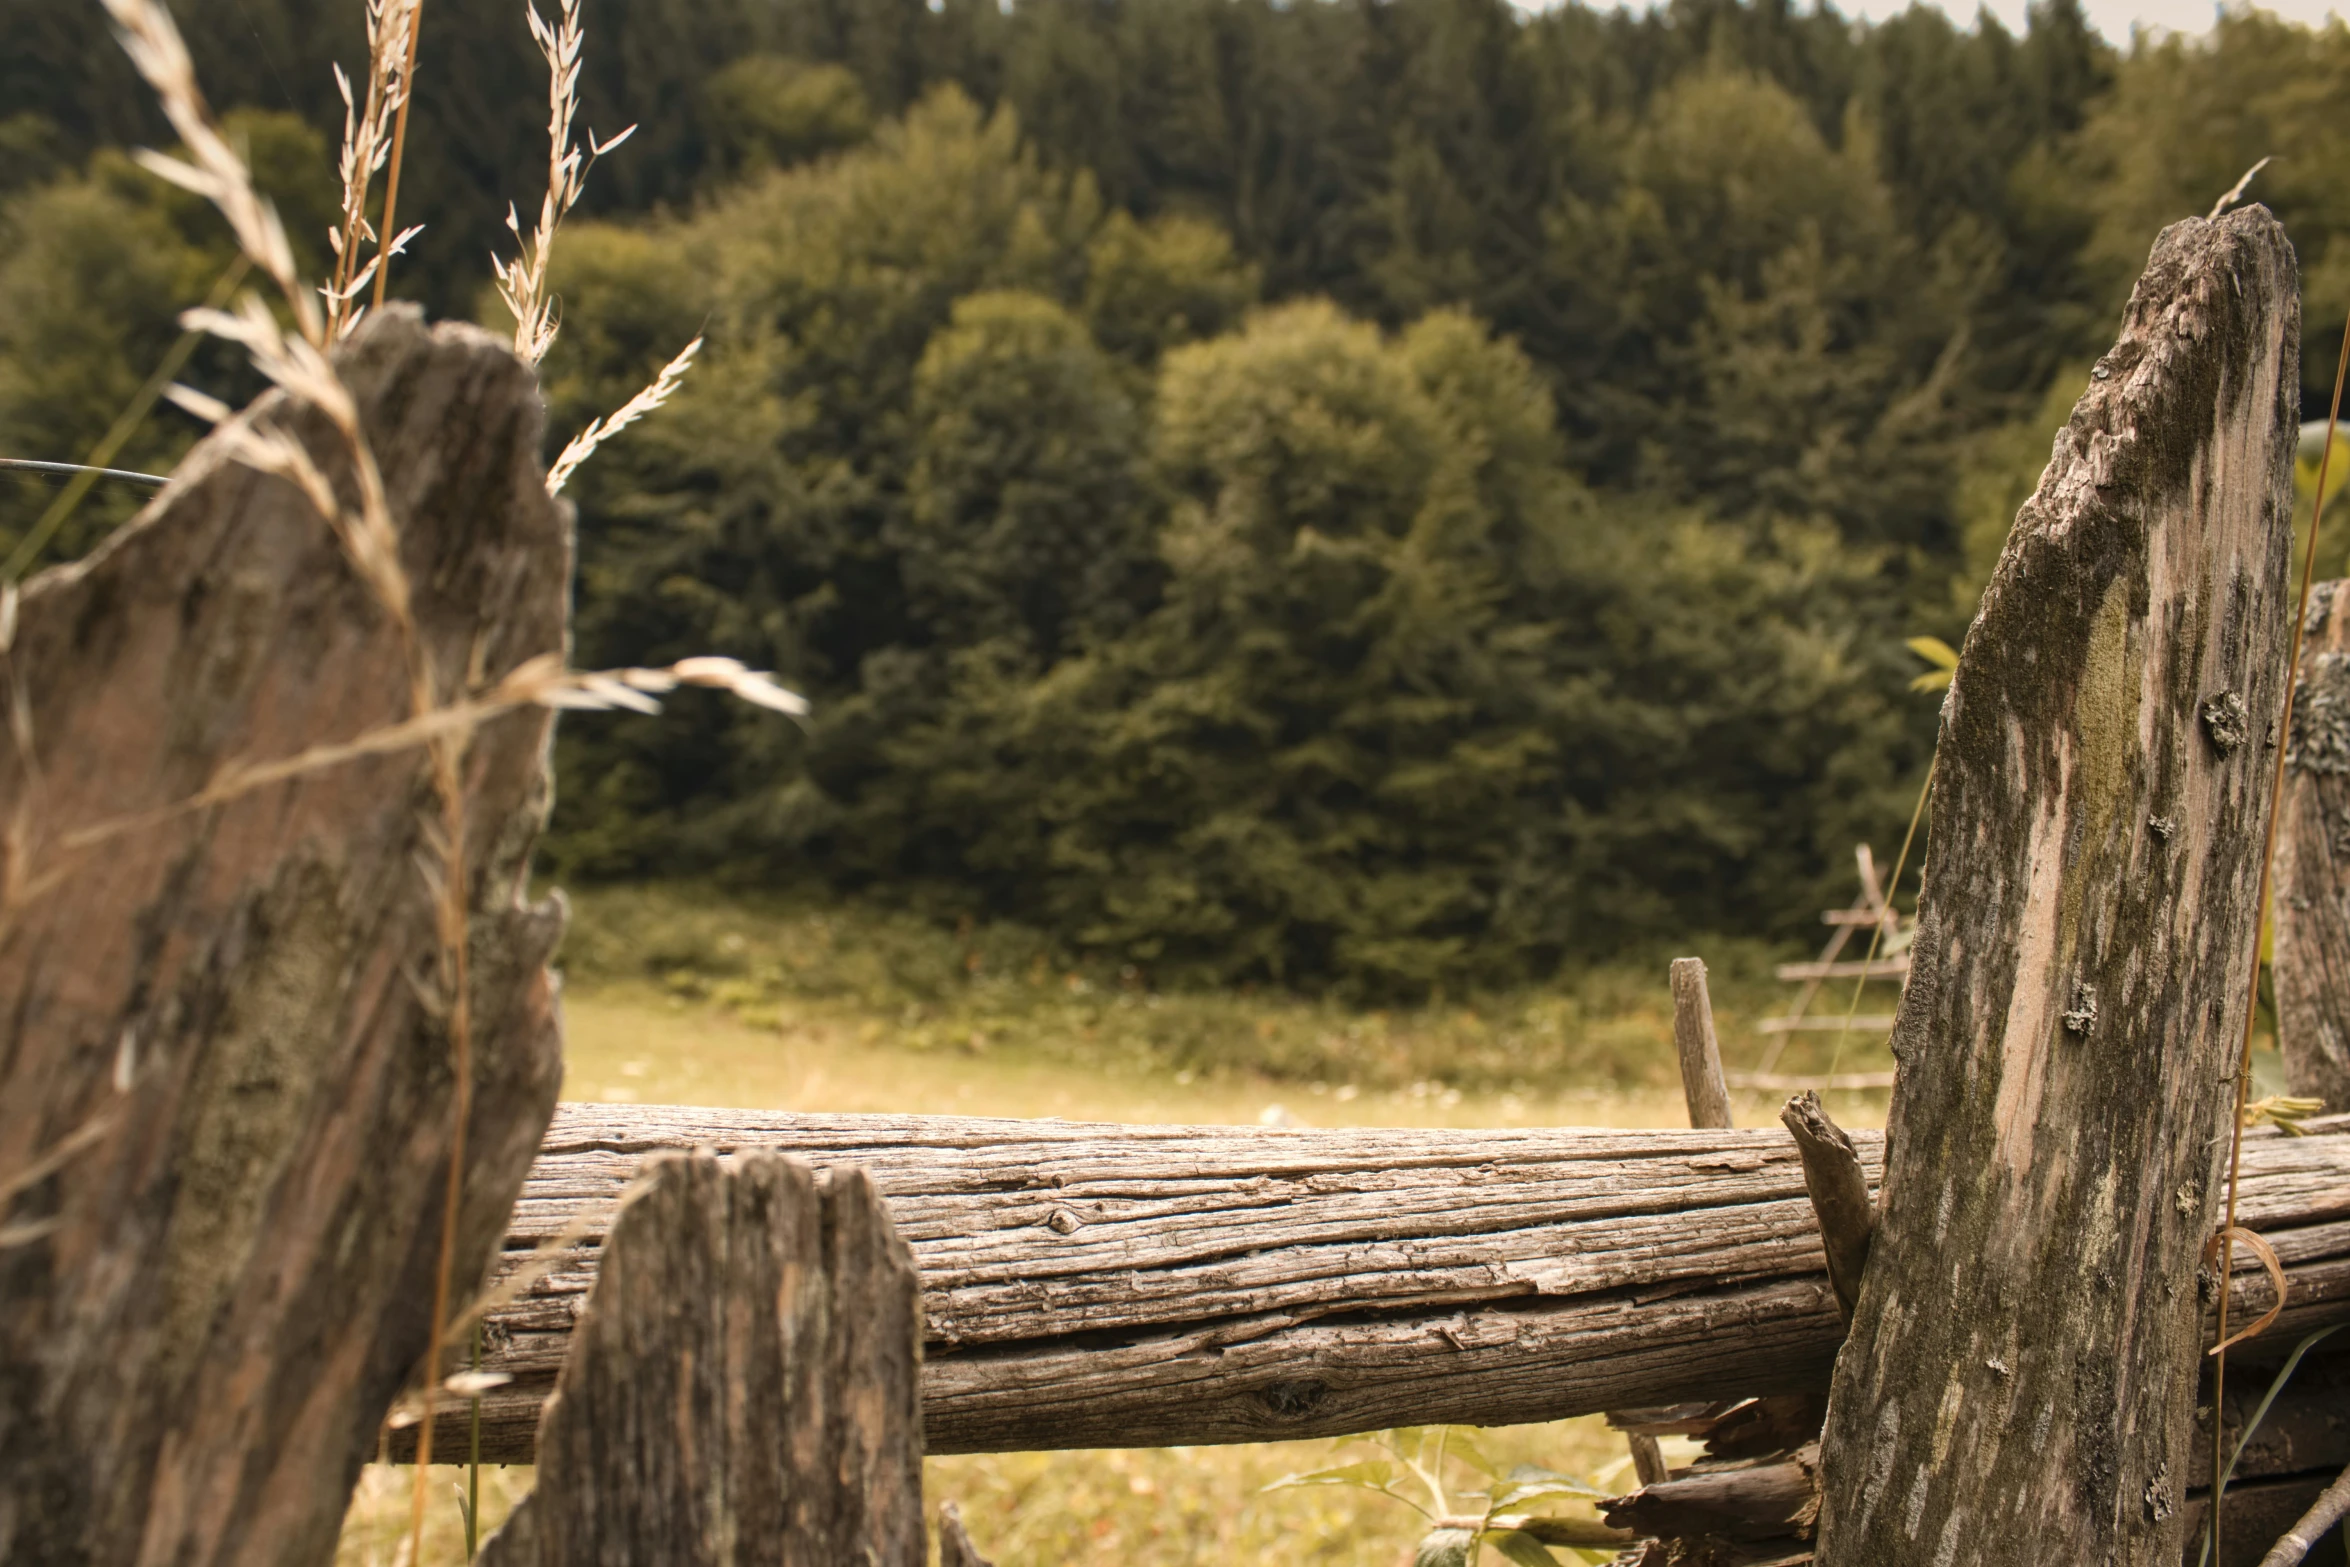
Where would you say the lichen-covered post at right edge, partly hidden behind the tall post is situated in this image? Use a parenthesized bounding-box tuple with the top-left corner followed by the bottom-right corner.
(2270, 583, 2350, 1109)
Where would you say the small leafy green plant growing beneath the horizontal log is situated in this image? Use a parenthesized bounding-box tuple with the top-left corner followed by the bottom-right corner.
(1264, 1426, 1617, 1567)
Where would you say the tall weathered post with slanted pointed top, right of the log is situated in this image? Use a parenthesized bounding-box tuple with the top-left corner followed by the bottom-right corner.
(1819, 207, 2301, 1567)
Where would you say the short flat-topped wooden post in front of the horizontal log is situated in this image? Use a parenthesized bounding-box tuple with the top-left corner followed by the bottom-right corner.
(482, 1154, 928, 1567)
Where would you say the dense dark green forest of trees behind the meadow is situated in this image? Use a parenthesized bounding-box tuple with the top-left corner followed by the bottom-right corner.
(0, 0, 2350, 991)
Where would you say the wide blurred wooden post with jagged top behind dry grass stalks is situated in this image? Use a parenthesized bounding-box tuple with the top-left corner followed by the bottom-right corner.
(0, 310, 571, 1567)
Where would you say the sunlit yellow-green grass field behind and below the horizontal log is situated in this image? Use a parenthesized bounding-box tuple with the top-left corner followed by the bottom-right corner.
(336, 888, 1889, 1567)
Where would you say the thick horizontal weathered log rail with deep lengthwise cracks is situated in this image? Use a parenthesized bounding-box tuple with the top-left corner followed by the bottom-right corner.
(392, 1104, 2350, 1461)
